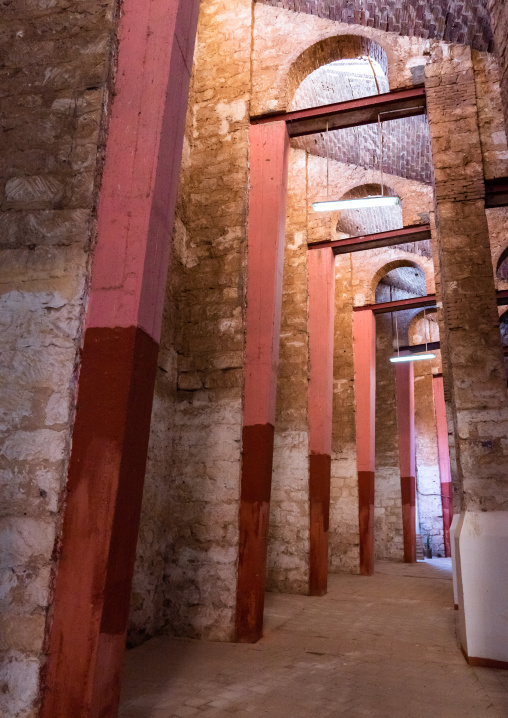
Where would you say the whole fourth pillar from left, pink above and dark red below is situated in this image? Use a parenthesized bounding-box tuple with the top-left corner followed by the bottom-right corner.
(353, 310, 376, 576)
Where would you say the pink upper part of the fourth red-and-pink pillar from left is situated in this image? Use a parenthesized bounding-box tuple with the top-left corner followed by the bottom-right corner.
(353, 310, 376, 471)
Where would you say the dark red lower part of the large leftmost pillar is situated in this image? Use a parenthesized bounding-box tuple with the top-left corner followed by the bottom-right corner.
(40, 327, 158, 718)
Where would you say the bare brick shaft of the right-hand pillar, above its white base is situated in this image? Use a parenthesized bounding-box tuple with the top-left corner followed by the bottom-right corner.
(426, 47, 508, 510)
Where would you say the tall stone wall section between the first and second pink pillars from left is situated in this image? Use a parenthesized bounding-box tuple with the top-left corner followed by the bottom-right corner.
(130, 0, 252, 643)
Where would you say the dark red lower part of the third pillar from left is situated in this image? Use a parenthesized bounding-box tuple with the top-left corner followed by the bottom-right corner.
(309, 454, 332, 596)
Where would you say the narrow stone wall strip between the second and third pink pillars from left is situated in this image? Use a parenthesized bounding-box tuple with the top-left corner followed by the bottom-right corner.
(267, 149, 310, 594)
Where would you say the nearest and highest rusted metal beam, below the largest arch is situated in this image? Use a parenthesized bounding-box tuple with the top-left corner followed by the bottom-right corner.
(251, 85, 427, 137)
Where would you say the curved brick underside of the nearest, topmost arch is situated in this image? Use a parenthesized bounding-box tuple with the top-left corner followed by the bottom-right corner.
(286, 35, 388, 108)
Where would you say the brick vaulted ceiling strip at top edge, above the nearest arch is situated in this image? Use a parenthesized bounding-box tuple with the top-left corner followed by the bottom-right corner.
(257, 0, 492, 50)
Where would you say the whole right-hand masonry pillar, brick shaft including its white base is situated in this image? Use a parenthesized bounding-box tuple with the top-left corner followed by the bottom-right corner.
(426, 46, 508, 668)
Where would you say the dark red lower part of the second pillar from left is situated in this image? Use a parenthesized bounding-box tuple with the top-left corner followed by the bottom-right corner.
(236, 424, 274, 643)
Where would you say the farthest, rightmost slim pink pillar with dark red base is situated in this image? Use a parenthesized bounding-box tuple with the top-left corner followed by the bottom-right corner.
(432, 374, 453, 557)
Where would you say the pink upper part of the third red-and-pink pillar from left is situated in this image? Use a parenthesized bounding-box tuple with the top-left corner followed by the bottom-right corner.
(308, 248, 335, 455)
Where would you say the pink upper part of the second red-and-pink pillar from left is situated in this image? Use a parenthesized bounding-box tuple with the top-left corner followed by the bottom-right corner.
(243, 122, 289, 426)
